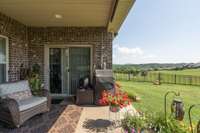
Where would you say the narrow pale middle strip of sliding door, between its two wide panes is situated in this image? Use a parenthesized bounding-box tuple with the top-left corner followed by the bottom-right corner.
(62, 48, 69, 95)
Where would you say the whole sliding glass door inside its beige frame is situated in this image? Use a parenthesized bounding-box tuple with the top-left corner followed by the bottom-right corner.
(49, 47, 90, 96)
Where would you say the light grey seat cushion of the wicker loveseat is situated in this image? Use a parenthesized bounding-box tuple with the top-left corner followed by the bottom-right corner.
(17, 96, 47, 111)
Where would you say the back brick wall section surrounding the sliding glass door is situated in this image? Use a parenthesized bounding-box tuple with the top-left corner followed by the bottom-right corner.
(28, 27, 112, 79)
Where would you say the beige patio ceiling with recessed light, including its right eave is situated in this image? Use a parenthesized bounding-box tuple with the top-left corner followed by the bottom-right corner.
(0, 0, 134, 32)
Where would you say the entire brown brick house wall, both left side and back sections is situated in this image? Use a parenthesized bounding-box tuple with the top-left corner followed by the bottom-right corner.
(0, 13, 113, 81)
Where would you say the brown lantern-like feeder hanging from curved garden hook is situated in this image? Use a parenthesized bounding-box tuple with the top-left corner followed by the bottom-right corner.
(171, 99, 185, 121)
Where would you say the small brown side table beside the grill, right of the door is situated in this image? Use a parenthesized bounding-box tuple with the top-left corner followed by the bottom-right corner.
(76, 89, 94, 105)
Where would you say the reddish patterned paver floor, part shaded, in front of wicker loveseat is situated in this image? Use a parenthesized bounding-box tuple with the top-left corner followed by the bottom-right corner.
(0, 104, 82, 133)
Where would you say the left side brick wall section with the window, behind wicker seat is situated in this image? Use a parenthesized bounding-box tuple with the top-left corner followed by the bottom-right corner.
(0, 13, 28, 81)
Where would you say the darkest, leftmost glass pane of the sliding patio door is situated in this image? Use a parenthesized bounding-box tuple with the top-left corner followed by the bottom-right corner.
(49, 48, 62, 94)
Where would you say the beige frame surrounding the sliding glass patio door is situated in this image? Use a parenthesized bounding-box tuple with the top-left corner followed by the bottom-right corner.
(44, 44, 93, 98)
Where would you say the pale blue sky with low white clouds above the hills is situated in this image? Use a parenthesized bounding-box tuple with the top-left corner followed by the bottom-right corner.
(113, 0, 200, 64)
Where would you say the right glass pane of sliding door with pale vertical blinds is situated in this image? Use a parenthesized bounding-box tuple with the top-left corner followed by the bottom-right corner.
(69, 48, 90, 94)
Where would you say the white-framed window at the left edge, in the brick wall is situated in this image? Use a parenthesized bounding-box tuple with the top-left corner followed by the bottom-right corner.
(0, 36, 8, 83)
